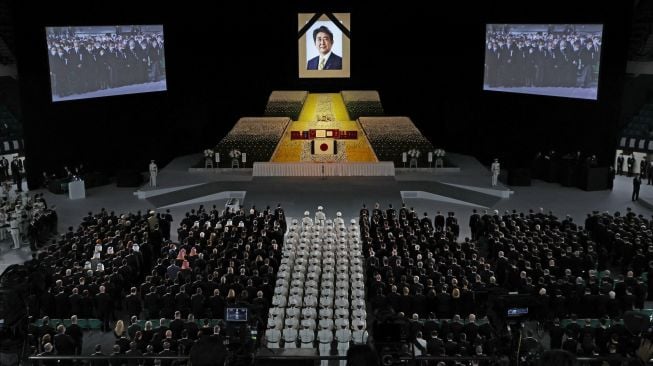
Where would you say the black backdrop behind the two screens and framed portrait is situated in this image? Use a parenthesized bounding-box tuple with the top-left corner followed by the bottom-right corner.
(13, 0, 632, 185)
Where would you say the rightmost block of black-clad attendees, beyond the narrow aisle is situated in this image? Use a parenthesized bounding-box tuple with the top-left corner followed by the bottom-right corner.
(481, 210, 653, 318)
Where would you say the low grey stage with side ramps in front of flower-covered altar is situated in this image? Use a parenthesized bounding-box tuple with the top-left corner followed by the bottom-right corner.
(134, 154, 512, 212)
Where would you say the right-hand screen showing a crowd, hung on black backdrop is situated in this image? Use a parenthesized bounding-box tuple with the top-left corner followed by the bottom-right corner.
(483, 24, 603, 99)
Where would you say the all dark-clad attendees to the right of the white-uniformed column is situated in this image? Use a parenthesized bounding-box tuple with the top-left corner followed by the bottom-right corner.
(360, 204, 653, 356)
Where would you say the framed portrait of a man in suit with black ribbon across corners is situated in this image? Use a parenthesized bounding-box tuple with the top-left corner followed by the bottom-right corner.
(297, 13, 351, 78)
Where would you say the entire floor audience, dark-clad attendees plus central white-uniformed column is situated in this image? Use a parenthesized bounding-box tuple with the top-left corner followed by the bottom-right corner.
(28, 200, 653, 364)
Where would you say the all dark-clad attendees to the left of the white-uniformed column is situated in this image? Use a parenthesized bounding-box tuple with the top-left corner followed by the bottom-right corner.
(29, 206, 285, 364)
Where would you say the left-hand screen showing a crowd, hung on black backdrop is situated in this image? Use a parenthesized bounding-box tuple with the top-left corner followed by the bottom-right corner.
(46, 25, 166, 102)
